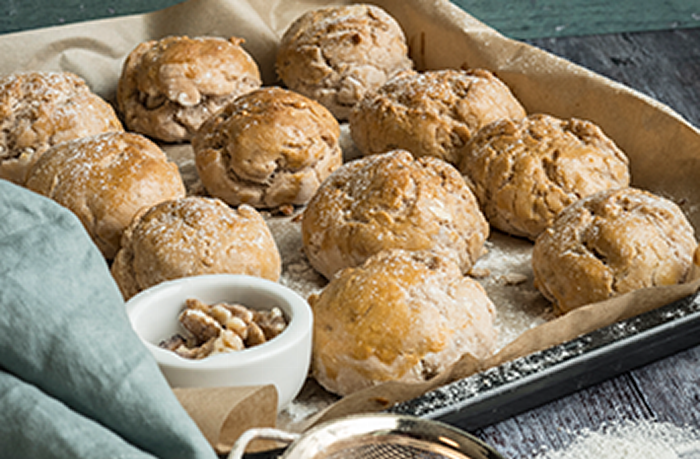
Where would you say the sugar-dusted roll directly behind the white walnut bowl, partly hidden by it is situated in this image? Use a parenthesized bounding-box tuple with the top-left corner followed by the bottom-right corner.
(112, 196, 282, 299)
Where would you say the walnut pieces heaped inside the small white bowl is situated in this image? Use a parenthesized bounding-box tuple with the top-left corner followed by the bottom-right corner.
(160, 298, 288, 359)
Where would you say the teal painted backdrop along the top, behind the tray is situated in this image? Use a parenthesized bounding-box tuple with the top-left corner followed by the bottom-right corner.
(0, 0, 700, 39)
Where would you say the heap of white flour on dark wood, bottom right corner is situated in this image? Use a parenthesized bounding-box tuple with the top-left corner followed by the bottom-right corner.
(533, 420, 700, 459)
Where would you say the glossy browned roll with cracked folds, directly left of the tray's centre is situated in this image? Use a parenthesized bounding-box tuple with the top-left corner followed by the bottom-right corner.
(192, 87, 343, 209)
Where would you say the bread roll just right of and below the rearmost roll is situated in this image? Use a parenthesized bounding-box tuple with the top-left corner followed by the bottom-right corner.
(350, 69, 525, 165)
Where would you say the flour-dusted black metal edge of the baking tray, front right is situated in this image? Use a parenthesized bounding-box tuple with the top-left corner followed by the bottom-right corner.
(387, 292, 700, 430)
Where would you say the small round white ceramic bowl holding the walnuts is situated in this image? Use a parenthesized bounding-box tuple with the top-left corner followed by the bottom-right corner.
(126, 274, 313, 409)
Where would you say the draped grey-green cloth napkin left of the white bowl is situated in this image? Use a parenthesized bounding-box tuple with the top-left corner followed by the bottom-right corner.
(0, 180, 216, 459)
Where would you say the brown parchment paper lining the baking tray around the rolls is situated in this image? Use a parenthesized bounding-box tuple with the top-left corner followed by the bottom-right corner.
(0, 0, 700, 450)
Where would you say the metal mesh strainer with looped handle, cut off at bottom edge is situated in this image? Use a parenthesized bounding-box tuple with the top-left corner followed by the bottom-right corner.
(228, 414, 503, 459)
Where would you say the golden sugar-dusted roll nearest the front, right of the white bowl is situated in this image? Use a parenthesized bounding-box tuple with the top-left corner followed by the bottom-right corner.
(309, 250, 497, 395)
